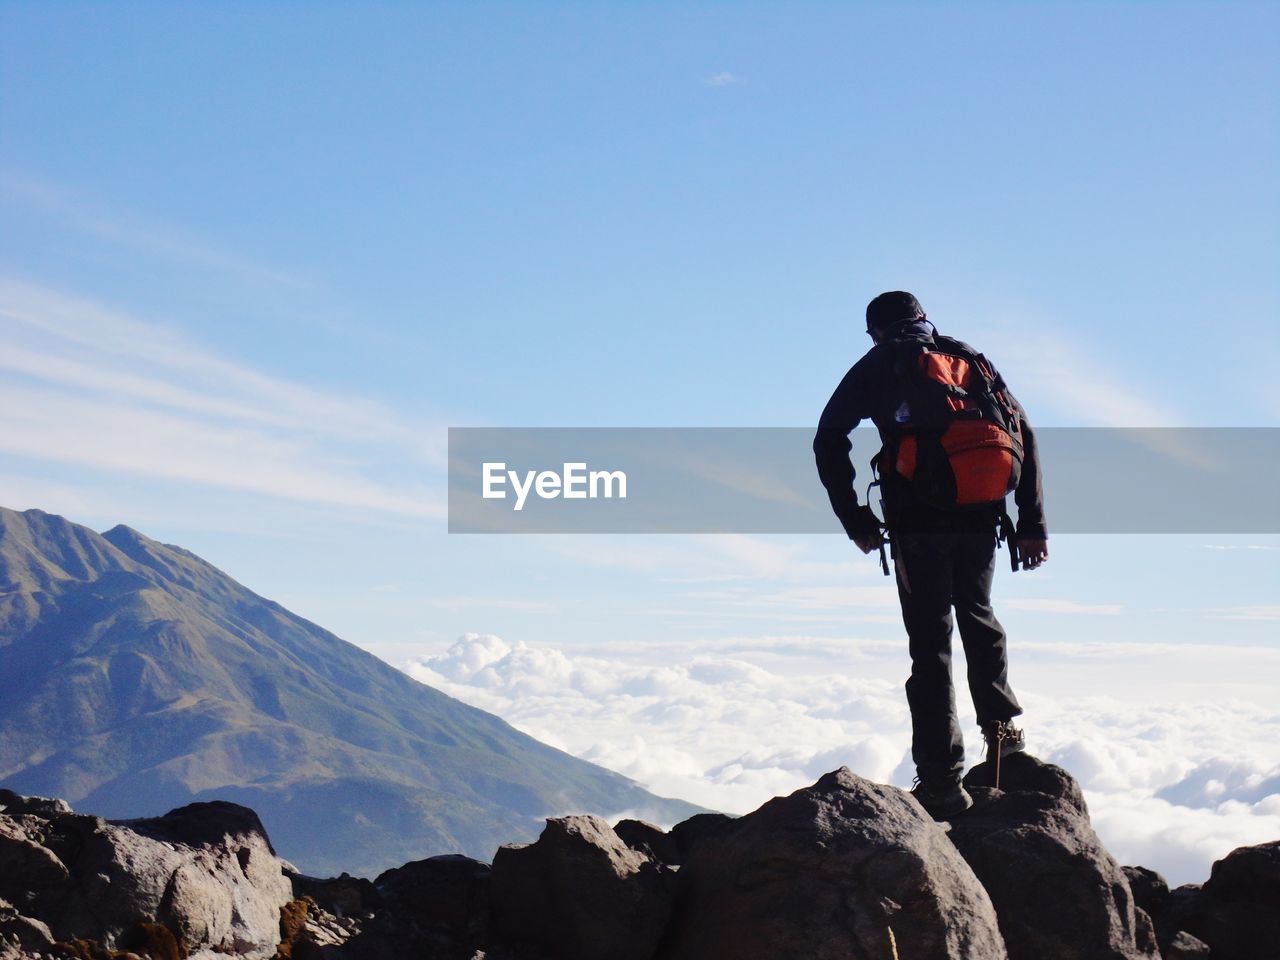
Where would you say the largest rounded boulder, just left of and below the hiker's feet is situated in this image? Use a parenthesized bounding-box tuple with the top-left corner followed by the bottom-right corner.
(662, 767, 1006, 960)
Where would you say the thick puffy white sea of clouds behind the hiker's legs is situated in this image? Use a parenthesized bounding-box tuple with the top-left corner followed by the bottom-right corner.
(406, 634, 1280, 884)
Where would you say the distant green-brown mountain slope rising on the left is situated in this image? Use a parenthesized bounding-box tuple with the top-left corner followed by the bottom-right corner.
(0, 508, 698, 874)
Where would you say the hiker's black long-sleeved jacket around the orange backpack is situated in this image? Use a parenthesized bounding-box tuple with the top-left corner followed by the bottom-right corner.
(813, 320, 1046, 539)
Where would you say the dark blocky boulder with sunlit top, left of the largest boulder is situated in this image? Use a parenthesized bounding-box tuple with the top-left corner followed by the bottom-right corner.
(492, 817, 672, 960)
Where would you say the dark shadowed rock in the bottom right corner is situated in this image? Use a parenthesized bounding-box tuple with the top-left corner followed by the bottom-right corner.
(1174, 840, 1280, 960)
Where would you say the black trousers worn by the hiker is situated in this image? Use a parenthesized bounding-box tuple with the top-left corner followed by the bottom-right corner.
(893, 530, 1023, 782)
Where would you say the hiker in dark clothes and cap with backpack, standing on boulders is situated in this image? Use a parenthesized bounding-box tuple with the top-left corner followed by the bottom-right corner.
(813, 291, 1048, 819)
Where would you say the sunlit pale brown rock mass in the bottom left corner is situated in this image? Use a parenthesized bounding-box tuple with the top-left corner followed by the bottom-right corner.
(0, 803, 292, 957)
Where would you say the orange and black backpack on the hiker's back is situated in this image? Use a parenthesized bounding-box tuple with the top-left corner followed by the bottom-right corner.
(878, 337, 1023, 508)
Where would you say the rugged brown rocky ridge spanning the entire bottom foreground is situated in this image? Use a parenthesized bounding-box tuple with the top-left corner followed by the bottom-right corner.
(0, 754, 1280, 960)
